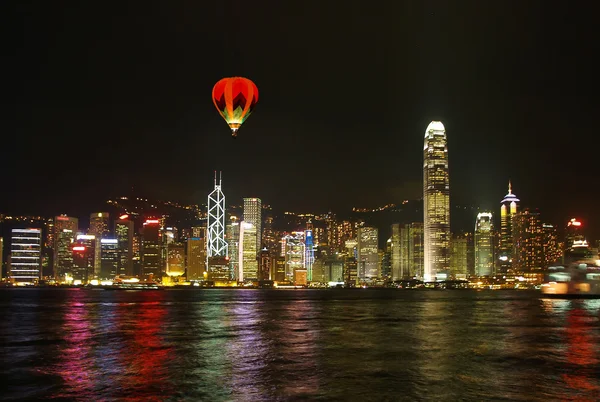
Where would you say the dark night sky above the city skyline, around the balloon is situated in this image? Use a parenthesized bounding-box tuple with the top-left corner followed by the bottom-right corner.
(0, 0, 600, 236)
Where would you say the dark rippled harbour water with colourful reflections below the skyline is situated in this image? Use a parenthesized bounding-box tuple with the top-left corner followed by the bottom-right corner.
(0, 289, 600, 401)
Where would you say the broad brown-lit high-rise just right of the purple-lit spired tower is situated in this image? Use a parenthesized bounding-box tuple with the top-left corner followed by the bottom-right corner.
(512, 209, 544, 273)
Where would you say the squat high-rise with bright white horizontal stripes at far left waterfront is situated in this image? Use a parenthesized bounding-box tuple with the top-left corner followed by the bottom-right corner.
(10, 228, 42, 284)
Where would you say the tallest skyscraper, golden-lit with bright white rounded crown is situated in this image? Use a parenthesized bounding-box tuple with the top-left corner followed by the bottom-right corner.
(423, 121, 450, 281)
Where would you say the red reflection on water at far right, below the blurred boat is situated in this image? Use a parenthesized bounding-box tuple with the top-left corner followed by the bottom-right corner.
(562, 309, 600, 401)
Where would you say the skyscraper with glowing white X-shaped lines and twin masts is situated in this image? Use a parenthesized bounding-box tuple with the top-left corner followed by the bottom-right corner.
(206, 172, 228, 264)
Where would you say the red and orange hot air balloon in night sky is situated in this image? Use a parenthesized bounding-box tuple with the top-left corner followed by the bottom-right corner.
(213, 77, 258, 138)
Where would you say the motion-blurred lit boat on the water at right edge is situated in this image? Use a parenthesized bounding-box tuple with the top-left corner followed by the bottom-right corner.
(540, 242, 600, 298)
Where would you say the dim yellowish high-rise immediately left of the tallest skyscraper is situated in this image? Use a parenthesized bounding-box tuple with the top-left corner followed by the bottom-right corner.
(392, 222, 425, 280)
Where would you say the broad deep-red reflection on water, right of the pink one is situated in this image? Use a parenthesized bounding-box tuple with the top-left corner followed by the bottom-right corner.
(119, 291, 171, 401)
